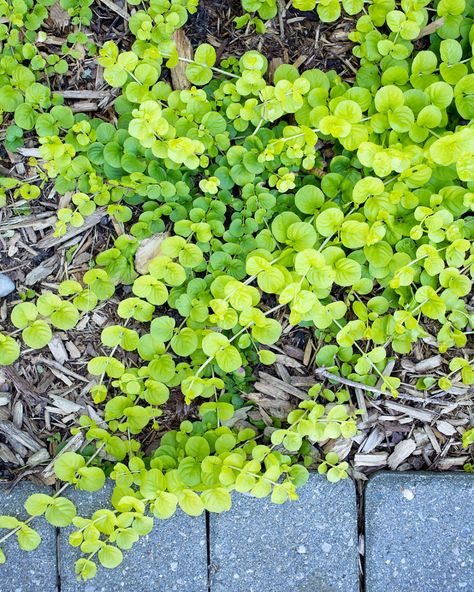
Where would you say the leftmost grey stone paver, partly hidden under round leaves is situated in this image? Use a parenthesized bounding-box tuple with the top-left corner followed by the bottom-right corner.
(0, 481, 57, 592)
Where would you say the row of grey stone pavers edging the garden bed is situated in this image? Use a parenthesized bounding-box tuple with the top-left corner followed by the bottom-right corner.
(0, 473, 474, 592)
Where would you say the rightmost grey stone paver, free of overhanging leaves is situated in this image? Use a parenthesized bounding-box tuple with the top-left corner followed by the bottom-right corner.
(365, 473, 474, 592)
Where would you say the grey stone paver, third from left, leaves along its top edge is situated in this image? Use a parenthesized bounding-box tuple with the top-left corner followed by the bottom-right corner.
(210, 475, 359, 592)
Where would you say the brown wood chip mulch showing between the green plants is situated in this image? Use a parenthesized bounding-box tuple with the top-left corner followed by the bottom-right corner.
(0, 0, 474, 483)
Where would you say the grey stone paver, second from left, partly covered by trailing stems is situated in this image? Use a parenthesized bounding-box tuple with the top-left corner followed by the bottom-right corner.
(59, 488, 207, 592)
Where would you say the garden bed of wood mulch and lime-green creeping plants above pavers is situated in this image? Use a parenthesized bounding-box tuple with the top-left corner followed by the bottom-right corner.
(0, 0, 474, 579)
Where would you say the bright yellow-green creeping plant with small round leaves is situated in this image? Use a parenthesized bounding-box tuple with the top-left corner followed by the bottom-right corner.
(0, 0, 474, 579)
